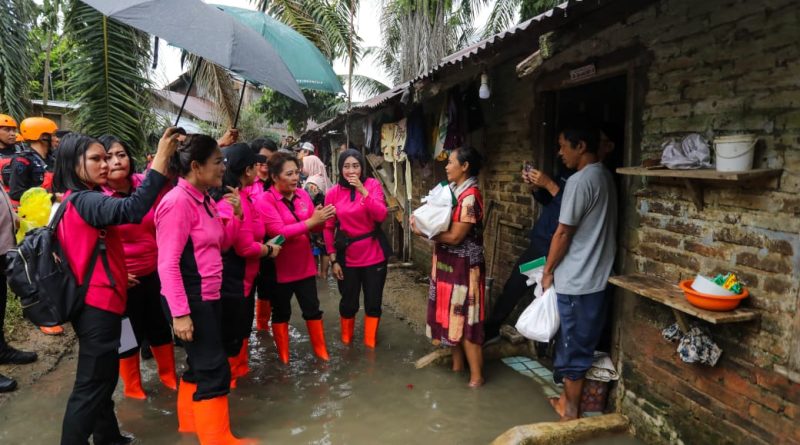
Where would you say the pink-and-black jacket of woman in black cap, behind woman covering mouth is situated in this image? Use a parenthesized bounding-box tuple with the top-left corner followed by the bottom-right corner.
(217, 190, 266, 297)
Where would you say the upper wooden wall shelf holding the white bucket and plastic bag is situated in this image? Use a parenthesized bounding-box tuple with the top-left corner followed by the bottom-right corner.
(617, 167, 783, 210)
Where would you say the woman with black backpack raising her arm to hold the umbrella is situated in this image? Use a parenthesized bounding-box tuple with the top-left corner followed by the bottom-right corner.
(53, 128, 178, 445)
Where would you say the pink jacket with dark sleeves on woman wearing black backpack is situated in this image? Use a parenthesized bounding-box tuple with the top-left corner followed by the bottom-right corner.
(56, 171, 167, 315)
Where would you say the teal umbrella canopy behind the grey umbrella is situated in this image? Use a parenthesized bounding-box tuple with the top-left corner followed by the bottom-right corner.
(211, 5, 344, 93)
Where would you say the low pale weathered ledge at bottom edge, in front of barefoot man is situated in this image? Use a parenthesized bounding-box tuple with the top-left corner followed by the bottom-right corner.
(492, 414, 628, 445)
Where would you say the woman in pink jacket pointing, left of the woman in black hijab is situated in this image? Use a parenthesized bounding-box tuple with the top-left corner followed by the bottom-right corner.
(256, 152, 335, 363)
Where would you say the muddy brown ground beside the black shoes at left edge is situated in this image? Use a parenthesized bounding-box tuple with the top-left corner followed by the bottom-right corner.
(0, 320, 77, 409)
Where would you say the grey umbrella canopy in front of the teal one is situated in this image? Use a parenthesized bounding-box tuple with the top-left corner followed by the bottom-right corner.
(82, 0, 306, 104)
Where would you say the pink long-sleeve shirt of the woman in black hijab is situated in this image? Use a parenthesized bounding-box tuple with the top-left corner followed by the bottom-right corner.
(324, 178, 388, 267)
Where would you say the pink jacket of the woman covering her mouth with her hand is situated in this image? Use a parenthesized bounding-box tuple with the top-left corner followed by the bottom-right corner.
(155, 178, 239, 317)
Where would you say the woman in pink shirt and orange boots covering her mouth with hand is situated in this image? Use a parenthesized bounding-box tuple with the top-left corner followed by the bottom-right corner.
(155, 134, 248, 445)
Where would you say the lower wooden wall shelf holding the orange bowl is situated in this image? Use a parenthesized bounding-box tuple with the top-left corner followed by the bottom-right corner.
(608, 274, 758, 332)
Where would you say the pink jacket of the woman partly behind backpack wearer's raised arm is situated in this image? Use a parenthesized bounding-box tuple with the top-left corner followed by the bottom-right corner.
(103, 173, 170, 277)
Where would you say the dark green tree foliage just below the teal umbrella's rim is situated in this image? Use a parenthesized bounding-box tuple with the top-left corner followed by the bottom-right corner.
(254, 90, 345, 134)
